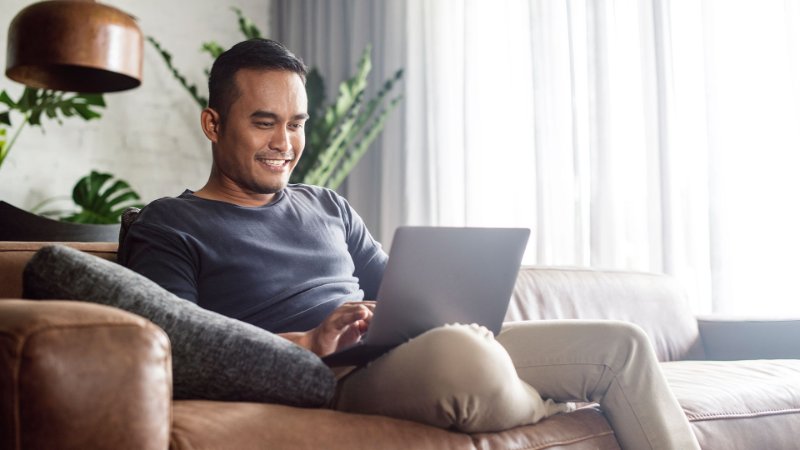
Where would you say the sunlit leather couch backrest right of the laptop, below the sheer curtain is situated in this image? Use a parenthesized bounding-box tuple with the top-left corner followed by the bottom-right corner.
(506, 266, 703, 361)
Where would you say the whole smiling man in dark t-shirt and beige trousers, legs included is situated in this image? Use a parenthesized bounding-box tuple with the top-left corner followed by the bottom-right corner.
(120, 39, 697, 449)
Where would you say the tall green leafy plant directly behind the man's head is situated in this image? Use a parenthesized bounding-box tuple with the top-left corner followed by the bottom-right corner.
(147, 8, 403, 189)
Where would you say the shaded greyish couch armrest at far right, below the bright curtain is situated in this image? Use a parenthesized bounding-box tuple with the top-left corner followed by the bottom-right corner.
(697, 317, 800, 361)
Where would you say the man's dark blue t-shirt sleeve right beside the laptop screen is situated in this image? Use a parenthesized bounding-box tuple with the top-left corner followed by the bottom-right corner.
(340, 197, 389, 300)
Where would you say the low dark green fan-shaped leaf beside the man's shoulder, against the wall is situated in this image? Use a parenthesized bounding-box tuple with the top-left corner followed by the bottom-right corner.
(33, 170, 144, 224)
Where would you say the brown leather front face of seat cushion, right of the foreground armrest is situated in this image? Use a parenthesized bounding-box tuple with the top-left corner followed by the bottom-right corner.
(170, 401, 473, 450)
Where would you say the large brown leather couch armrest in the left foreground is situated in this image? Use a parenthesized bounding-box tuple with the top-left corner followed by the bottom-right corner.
(0, 300, 172, 450)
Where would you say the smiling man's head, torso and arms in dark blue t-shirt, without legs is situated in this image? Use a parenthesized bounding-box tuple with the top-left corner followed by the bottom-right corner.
(120, 39, 387, 342)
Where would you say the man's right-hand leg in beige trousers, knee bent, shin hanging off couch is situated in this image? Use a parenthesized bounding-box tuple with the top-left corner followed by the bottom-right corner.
(497, 320, 699, 450)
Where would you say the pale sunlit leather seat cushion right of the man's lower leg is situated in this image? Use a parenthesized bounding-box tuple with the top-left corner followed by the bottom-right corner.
(662, 360, 800, 450)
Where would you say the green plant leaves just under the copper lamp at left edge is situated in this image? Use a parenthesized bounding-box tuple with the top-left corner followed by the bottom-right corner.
(0, 87, 106, 171)
